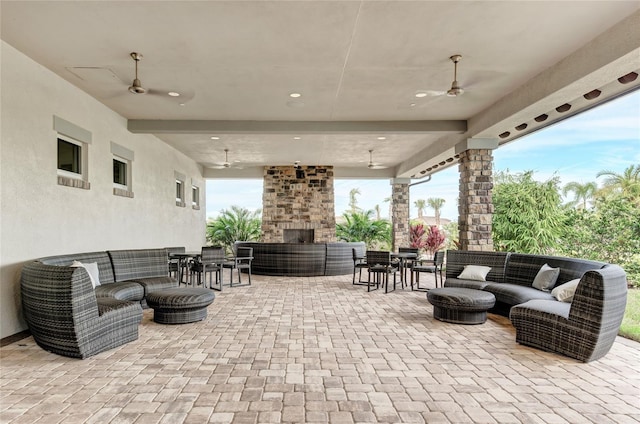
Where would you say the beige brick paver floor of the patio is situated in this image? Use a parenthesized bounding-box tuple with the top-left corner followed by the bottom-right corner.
(0, 276, 640, 424)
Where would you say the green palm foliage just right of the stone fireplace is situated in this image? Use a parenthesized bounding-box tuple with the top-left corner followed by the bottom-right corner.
(336, 210, 391, 249)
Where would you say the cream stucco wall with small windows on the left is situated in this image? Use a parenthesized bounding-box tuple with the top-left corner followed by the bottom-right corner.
(0, 42, 206, 338)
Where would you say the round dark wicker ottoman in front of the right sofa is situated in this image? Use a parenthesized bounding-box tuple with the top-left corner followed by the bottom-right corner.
(427, 287, 496, 324)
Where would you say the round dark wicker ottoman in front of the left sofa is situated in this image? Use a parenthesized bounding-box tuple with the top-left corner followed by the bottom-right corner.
(147, 287, 215, 324)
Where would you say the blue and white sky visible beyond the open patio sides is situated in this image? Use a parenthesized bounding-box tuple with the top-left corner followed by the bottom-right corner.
(206, 91, 640, 221)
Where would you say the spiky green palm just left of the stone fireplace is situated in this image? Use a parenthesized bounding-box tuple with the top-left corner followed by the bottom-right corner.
(207, 206, 262, 251)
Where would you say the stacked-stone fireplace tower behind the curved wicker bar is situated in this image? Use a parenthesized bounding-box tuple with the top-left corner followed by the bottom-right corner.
(262, 166, 336, 243)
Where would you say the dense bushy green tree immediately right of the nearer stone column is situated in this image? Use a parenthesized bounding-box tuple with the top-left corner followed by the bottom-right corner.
(493, 171, 563, 254)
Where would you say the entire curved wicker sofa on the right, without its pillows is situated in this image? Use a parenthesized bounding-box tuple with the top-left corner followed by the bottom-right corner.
(444, 250, 627, 362)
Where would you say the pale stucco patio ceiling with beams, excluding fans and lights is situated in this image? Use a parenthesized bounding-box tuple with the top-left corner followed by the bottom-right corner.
(0, 0, 640, 178)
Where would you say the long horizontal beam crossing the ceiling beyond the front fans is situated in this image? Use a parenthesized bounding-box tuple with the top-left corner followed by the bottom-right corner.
(127, 119, 467, 134)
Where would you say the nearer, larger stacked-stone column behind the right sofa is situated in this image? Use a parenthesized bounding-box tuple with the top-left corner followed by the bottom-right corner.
(458, 149, 493, 251)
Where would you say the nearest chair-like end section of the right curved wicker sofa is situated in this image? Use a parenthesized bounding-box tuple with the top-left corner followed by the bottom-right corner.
(510, 265, 627, 362)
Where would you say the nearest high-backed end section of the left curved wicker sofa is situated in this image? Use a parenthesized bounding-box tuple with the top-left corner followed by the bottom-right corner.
(20, 262, 142, 359)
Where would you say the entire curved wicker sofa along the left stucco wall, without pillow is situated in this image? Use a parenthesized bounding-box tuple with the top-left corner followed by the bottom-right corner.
(20, 249, 178, 358)
